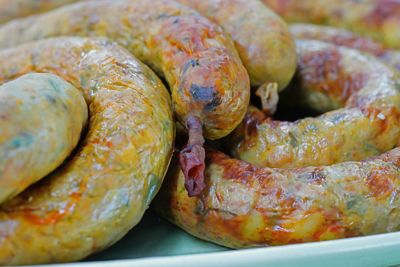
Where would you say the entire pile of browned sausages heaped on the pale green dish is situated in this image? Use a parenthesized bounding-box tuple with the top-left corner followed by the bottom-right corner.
(0, 0, 400, 264)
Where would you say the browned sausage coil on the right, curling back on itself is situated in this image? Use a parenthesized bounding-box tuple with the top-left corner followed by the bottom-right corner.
(153, 40, 400, 248)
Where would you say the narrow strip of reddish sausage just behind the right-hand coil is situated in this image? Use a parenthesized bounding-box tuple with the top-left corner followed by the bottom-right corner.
(289, 23, 400, 70)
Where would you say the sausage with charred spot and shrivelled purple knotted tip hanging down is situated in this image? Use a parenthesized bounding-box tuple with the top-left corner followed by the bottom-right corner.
(0, 0, 250, 195)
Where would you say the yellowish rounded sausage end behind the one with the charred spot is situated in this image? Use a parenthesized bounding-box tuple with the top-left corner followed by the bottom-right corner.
(175, 0, 297, 90)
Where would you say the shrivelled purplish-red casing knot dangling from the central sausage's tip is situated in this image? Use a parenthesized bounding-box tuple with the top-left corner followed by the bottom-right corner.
(179, 116, 206, 197)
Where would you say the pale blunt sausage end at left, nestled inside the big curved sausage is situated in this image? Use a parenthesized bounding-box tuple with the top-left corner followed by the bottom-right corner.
(0, 73, 88, 203)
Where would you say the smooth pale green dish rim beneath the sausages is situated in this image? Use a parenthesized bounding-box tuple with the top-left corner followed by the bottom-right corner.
(44, 232, 400, 267)
